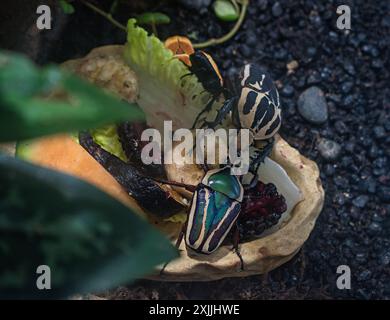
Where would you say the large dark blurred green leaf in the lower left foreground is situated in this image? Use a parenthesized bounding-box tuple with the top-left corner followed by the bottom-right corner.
(0, 155, 177, 298)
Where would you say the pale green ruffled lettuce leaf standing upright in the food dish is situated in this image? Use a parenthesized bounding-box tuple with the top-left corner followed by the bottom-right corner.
(124, 19, 218, 132)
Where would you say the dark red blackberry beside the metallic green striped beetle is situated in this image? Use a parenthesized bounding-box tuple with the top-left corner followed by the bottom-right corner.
(238, 181, 287, 241)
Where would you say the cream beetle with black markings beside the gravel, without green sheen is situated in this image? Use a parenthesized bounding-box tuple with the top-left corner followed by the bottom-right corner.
(202, 64, 281, 181)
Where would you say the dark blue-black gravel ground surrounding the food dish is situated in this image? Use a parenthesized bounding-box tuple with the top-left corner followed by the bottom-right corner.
(2, 0, 390, 299)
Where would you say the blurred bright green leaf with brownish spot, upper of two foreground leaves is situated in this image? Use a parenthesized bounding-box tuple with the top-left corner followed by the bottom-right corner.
(0, 51, 144, 142)
